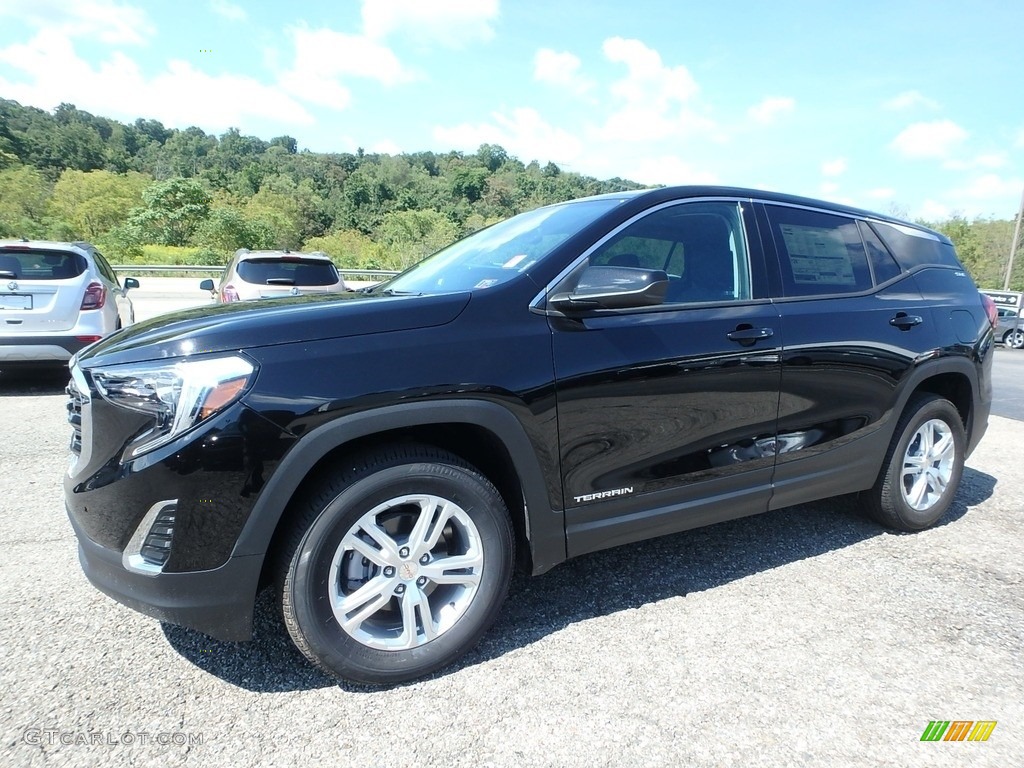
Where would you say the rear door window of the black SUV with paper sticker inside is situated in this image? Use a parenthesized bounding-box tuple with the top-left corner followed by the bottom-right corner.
(766, 206, 871, 296)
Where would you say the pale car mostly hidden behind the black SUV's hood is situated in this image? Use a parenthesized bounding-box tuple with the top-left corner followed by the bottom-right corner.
(200, 249, 348, 303)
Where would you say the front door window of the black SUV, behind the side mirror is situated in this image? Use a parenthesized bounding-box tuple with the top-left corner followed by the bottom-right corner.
(590, 202, 751, 303)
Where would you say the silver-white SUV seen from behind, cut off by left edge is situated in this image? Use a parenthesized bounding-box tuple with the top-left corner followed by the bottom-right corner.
(0, 240, 138, 369)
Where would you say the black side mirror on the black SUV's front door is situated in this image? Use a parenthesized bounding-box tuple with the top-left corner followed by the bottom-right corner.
(548, 266, 669, 312)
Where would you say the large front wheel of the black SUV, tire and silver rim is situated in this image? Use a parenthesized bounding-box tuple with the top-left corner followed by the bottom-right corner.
(279, 445, 515, 684)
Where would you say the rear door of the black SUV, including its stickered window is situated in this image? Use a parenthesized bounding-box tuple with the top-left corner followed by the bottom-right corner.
(761, 206, 934, 508)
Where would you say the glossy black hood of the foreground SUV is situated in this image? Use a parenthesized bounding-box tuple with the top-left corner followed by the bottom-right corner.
(77, 293, 471, 366)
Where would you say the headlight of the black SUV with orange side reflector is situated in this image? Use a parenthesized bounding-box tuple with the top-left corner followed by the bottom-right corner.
(91, 355, 256, 459)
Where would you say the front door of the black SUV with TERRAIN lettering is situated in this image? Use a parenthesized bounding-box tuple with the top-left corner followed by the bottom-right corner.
(551, 203, 782, 554)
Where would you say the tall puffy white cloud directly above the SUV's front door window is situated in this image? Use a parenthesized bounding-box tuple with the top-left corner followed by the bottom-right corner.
(599, 37, 716, 142)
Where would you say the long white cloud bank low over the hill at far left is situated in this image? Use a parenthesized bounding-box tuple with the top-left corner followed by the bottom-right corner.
(0, 30, 313, 130)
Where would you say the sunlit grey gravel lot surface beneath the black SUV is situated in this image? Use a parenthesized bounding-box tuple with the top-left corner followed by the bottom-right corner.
(0, 354, 1024, 768)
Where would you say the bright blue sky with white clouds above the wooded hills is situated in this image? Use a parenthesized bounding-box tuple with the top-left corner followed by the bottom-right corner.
(0, 0, 1024, 221)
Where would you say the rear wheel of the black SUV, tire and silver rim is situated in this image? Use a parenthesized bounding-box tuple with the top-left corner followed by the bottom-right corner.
(864, 393, 967, 532)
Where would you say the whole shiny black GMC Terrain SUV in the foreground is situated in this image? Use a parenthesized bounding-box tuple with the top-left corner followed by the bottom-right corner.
(65, 186, 995, 683)
